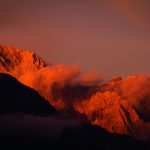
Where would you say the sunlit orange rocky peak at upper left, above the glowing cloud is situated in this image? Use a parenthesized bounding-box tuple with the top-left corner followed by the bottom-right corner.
(0, 46, 47, 72)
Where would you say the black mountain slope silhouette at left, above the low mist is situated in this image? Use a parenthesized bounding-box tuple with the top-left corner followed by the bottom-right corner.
(0, 73, 57, 116)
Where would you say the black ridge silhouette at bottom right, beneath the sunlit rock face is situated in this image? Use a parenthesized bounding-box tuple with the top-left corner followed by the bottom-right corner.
(58, 124, 150, 150)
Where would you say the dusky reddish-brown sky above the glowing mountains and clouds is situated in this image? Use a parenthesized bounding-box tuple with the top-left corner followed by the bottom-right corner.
(0, 0, 150, 79)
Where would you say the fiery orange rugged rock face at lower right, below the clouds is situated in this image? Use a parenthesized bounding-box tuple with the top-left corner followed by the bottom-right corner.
(75, 92, 139, 135)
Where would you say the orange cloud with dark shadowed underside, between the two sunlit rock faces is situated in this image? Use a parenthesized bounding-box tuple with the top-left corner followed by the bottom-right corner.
(9, 63, 101, 111)
